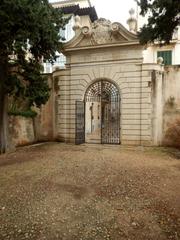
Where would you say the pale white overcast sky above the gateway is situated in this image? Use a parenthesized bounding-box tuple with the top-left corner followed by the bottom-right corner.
(49, 0, 136, 25)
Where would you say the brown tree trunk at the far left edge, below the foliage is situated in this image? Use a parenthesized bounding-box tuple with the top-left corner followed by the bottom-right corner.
(0, 63, 8, 154)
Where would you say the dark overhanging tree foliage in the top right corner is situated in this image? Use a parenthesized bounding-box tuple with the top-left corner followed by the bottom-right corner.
(137, 0, 180, 44)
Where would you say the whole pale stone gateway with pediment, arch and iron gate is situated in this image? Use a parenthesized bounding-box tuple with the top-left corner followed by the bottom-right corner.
(53, 19, 163, 145)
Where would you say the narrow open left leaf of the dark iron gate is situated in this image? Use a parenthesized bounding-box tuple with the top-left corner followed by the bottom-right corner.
(75, 101, 85, 144)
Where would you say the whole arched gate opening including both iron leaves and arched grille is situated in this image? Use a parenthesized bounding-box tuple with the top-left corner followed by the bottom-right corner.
(76, 80, 120, 144)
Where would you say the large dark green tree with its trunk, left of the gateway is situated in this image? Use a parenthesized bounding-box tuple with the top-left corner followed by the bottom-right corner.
(0, 0, 67, 153)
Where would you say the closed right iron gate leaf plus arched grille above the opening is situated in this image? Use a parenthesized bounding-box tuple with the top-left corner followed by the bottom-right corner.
(85, 80, 120, 144)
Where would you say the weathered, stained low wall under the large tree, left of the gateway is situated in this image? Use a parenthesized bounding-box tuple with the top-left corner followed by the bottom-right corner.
(9, 75, 56, 147)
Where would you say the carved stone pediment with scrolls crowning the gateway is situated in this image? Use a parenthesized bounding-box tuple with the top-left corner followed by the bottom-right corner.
(65, 18, 138, 48)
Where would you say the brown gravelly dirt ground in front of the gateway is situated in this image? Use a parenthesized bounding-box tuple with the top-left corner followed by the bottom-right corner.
(0, 143, 180, 240)
